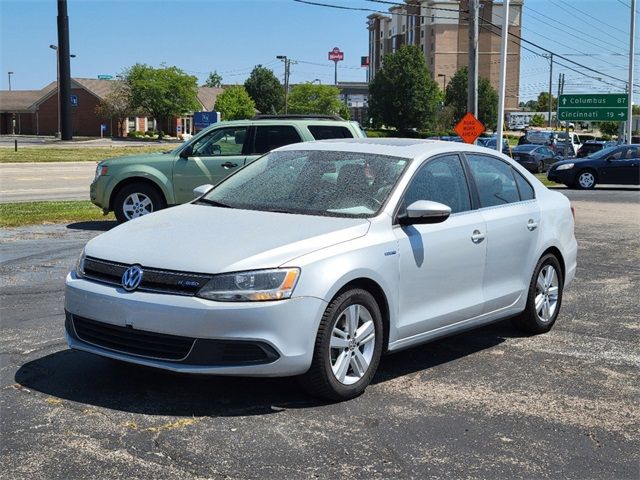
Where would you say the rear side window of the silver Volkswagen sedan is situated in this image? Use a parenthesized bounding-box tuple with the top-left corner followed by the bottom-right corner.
(467, 154, 520, 207)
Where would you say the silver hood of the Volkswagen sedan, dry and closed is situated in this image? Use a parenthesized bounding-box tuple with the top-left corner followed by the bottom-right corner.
(85, 204, 370, 274)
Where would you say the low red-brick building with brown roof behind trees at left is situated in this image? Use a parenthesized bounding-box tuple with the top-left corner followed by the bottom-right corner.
(0, 78, 222, 137)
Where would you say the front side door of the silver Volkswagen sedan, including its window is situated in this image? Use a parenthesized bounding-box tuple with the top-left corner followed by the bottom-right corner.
(394, 154, 486, 338)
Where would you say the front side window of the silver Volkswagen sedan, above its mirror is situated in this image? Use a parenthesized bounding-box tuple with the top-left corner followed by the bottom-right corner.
(404, 155, 471, 213)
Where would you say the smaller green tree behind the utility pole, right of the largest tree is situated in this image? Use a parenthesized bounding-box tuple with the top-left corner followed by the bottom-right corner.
(444, 67, 498, 128)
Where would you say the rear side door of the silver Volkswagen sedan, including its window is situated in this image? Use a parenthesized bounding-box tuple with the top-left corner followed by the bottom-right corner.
(465, 153, 540, 313)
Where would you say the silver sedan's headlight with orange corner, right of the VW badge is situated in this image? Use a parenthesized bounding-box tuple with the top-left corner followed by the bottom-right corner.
(197, 268, 300, 302)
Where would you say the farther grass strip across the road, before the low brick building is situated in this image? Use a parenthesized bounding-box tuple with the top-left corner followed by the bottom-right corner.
(0, 145, 169, 163)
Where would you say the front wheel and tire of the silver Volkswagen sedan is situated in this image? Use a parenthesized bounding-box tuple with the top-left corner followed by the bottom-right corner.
(299, 289, 384, 401)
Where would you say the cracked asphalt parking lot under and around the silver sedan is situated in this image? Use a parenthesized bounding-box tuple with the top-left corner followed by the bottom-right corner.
(0, 189, 640, 479)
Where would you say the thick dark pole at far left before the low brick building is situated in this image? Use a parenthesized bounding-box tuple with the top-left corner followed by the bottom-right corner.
(57, 0, 73, 140)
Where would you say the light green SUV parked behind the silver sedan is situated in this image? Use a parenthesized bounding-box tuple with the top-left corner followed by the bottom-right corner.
(90, 115, 365, 222)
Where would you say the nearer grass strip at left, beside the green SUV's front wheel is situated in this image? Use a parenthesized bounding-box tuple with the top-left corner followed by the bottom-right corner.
(0, 200, 115, 228)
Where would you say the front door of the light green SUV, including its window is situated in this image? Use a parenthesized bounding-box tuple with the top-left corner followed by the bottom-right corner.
(173, 126, 248, 203)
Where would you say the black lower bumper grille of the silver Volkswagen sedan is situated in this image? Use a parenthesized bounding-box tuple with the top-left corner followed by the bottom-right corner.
(65, 312, 280, 366)
